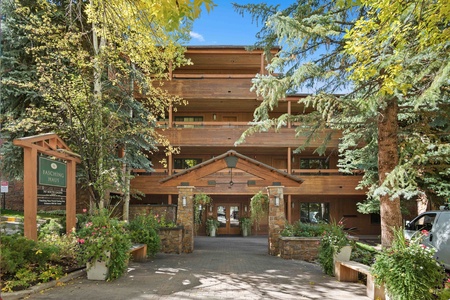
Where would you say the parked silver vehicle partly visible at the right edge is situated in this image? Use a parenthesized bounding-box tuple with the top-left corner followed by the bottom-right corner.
(405, 204, 450, 270)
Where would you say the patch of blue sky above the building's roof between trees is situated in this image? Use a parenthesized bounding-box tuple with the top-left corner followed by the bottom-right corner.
(188, 0, 280, 46)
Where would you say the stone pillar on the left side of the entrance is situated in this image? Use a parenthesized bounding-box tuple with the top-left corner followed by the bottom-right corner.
(177, 186, 194, 253)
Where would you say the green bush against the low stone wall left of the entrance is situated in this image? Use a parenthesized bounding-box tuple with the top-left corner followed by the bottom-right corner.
(128, 215, 161, 256)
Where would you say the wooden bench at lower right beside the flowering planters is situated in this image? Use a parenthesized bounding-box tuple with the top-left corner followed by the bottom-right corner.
(334, 260, 385, 300)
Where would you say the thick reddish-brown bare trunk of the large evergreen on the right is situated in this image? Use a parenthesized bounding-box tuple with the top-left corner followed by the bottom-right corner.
(378, 98, 402, 247)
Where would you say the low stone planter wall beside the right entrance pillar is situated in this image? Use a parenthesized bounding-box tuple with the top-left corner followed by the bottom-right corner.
(279, 237, 320, 261)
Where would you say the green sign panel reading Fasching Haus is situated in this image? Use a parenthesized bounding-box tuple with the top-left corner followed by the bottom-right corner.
(38, 156, 66, 187)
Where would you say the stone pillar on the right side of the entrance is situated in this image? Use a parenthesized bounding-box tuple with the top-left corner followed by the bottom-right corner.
(267, 186, 286, 256)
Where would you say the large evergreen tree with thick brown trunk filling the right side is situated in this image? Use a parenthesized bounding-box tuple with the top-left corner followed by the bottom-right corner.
(235, 0, 450, 246)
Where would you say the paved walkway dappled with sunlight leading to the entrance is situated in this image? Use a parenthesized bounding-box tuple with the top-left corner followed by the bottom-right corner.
(10, 236, 369, 300)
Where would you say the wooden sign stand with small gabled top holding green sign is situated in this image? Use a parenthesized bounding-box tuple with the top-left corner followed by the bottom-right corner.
(14, 133, 80, 240)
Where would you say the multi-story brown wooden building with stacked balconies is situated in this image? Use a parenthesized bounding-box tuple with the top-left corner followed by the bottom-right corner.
(131, 46, 380, 235)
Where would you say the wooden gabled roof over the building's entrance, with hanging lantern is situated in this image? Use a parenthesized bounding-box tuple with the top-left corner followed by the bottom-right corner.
(160, 150, 303, 187)
